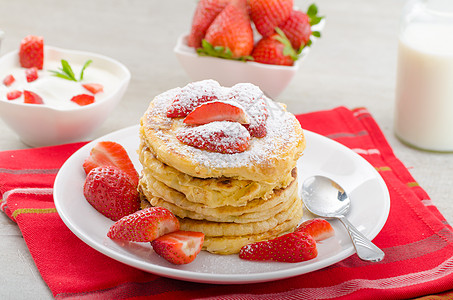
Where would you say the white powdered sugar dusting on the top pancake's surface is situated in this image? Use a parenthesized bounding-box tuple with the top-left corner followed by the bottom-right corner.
(147, 83, 301, 169)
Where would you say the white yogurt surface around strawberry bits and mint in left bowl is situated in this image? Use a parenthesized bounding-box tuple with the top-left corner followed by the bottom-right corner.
(0, 59, 120, 110)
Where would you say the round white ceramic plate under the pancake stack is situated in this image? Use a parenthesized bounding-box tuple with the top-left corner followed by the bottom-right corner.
(54, 126, 390, 284)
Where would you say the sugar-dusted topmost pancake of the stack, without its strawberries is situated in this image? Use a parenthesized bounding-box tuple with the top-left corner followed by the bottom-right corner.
(140, 79, 305, 184)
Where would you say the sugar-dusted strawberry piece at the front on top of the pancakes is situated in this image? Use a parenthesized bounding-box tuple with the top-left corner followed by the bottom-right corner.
(176, 121, 250, 154)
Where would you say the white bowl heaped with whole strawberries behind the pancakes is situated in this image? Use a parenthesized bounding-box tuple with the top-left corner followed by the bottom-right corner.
(174, 0, 324, 98)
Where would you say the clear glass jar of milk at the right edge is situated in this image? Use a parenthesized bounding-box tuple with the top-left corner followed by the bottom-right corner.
(395, 0, 453, 152)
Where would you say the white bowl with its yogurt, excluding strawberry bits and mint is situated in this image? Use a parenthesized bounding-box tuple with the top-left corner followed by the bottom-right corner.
(0, 46, 131, 147)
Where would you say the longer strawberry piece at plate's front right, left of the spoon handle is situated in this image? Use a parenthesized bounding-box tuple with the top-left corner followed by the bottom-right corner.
(239, 232, 318, 263)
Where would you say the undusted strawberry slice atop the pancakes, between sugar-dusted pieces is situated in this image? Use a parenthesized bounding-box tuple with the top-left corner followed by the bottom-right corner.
(184, 101, 250, 125)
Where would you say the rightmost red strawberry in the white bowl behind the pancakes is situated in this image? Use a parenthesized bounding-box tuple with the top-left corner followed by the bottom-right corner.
(278, 10, 311, 51)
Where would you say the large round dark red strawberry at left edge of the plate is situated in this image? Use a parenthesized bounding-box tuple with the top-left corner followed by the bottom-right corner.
(83, 166, 140, 221)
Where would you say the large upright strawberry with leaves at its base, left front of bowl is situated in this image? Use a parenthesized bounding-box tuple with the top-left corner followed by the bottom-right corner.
(198, 0, 254, 59)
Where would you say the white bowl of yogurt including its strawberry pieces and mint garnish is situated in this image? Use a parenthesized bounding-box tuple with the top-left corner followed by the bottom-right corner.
(0, 36, 131, 147)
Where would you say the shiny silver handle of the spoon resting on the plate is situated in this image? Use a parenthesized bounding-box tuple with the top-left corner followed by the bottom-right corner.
(338, 216, 385, 262)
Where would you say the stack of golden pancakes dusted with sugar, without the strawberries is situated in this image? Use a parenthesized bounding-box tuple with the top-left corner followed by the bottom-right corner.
(139, 82, 305, 254)
